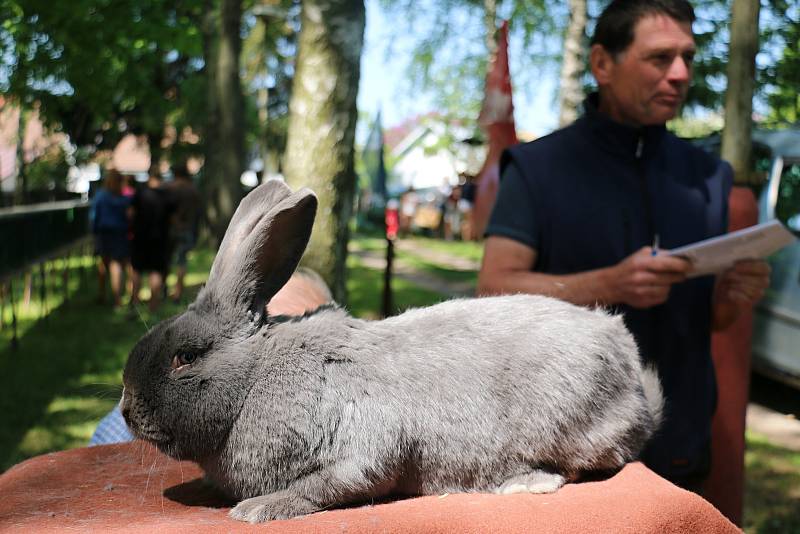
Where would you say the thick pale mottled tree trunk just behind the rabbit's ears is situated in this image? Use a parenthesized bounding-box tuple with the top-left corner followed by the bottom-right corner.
(284, 0, 366, 303)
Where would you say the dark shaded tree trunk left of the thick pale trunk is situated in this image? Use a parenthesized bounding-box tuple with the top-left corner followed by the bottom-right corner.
(203, 0, 245, 245)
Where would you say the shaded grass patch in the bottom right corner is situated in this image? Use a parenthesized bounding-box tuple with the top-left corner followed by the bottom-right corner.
(744, 434, 800, 534)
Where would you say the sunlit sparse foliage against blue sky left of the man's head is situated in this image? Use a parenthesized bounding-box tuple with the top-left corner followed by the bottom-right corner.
(382, 0, 568, 124)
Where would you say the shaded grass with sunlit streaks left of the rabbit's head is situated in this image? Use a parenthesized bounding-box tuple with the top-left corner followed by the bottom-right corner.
(0, 251, 216, 471)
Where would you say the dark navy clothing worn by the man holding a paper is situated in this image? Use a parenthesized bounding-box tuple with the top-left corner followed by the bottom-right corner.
(486, 99, 732, 486)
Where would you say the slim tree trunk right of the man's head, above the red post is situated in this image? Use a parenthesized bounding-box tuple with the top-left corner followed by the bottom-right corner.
(722, 0, 761, 185)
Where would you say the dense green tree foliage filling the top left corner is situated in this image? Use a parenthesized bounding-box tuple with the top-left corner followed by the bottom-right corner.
(0, 0, 203, 159)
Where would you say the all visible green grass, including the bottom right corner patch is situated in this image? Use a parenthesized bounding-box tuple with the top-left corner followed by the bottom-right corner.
(0, 235, 800, 533)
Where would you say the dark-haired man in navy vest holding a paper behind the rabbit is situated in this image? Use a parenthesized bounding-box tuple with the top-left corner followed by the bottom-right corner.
(478, 0, 769, 491)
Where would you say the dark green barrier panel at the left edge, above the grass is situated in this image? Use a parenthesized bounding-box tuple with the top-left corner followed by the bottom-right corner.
(0, 201, 90, 280)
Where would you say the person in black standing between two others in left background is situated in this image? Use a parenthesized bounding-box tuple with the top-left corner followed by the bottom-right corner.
(131, 168, 175, 311)
